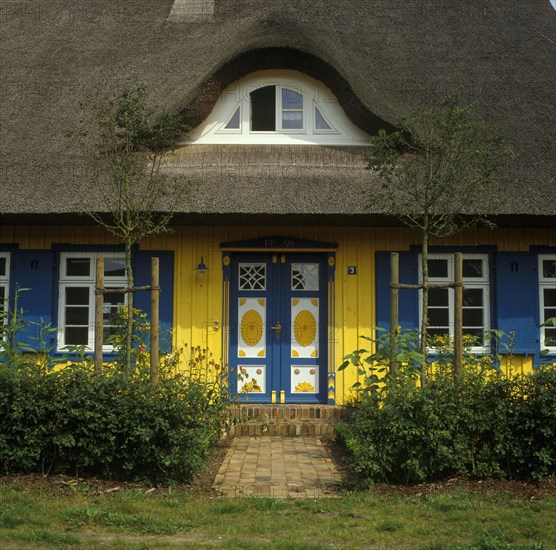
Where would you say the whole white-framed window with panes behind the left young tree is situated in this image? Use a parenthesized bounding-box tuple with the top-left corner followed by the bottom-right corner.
(58, 252, 127, 351)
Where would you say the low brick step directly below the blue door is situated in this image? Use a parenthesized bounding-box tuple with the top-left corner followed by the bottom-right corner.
(228, 404, 349, 436)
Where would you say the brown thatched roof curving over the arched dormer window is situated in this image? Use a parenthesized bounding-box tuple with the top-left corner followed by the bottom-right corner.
(0, 0, 556, 223)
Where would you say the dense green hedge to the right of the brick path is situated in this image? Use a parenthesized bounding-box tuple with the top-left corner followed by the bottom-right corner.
(338, 366, 556, 486)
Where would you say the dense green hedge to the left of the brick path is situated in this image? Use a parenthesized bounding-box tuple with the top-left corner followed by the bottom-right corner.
(0, 363, 226, 483)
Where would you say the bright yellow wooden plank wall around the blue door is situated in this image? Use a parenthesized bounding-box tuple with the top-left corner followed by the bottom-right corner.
(0, 226, 556, 401)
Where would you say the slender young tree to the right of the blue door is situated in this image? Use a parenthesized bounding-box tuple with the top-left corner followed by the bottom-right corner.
(367, 89, 504, 376)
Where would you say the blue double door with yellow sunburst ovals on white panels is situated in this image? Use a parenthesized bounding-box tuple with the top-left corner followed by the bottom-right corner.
(229, 253, 328, 403)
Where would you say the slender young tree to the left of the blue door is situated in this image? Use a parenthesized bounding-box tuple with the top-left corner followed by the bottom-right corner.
(82, 86, 188, 369)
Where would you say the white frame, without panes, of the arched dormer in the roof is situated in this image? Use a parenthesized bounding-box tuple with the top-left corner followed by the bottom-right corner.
(185, 70, 371, 147)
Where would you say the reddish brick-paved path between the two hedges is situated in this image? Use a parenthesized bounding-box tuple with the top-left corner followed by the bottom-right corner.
(213, 436, 342, 498)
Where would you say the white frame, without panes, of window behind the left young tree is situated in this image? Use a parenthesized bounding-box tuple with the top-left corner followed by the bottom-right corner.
(58, 252, 127, 352)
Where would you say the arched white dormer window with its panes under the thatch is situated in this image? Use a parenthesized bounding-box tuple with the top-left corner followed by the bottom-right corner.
(184, 71, 369, 146)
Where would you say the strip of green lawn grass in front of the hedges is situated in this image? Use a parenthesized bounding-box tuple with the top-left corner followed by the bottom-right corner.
(0, 482, 556, 550)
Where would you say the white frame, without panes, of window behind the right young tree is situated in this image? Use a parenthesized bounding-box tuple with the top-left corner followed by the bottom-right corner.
(419, 252, 490, 354)
